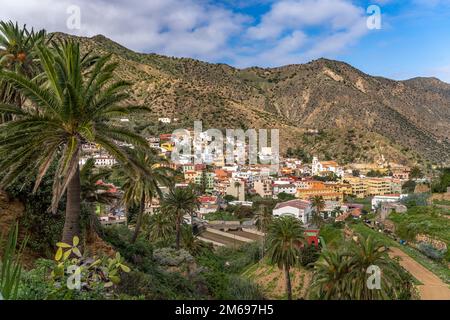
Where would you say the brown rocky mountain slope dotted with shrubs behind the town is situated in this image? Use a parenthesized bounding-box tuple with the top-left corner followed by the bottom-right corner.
(55, 34, 450, 165)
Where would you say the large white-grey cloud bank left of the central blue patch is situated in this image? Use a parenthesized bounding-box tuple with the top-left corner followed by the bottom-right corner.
(0, 0, 246, 60)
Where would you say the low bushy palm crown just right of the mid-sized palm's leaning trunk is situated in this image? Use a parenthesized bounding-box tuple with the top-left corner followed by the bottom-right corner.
(142, 212, 175, 241)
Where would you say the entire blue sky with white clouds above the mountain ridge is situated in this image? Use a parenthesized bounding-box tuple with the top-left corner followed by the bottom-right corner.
(0, 0, 450, 82)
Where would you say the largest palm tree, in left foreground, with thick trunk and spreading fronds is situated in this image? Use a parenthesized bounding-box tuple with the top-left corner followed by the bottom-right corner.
(0, 41, 148, 243)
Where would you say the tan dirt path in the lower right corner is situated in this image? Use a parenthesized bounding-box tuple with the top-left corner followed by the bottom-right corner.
(389, 247, 450, 300)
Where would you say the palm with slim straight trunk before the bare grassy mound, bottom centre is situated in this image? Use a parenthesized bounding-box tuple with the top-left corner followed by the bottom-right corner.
(267, 216, 304, 300)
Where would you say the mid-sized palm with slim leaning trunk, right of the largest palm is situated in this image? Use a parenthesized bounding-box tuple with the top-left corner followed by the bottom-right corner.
(118, 149, 174, 243)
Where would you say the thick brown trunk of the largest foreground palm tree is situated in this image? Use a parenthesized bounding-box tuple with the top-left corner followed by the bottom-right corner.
(62, 165, 81, 244)
